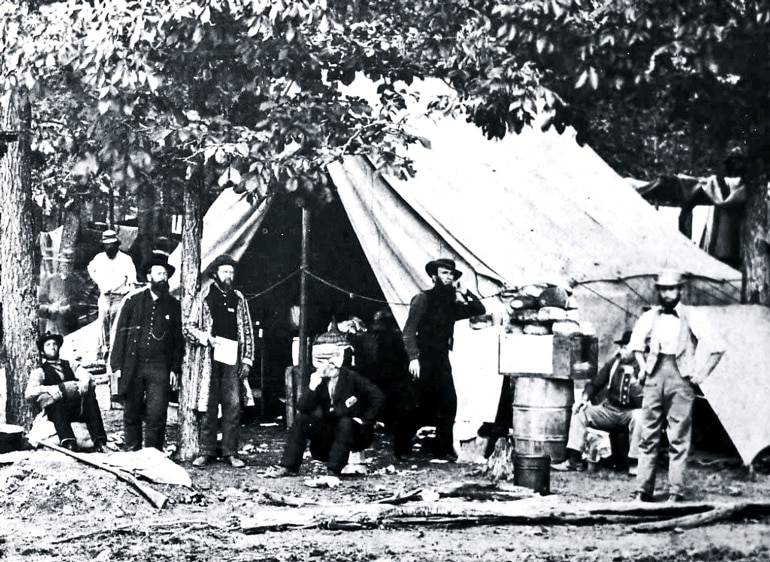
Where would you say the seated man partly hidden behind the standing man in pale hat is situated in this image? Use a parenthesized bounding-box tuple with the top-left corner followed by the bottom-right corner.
(551, 331, 642, 476)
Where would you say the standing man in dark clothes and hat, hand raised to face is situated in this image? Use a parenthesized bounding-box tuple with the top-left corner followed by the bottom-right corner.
(404, 258, 486, 461)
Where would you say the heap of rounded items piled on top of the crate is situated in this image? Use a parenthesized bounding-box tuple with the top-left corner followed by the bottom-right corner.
(503, 285, 581, 336)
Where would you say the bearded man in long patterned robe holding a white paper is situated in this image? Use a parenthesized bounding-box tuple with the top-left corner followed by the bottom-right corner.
(184, 254, 254, 468)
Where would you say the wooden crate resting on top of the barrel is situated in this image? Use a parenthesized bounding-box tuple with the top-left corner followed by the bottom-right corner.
(498, 334, 599, 380)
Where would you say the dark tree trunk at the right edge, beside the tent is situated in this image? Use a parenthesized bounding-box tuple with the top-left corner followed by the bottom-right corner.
(741, 177, 770, 304)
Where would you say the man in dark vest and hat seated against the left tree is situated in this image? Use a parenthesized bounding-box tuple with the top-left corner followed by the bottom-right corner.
(24, 333, 107, 453)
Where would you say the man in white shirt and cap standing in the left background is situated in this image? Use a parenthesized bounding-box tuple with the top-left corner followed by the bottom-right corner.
(88, 230, 136, 357)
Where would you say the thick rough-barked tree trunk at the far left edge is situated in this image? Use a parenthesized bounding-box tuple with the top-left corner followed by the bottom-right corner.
(0, 92, 38, 426)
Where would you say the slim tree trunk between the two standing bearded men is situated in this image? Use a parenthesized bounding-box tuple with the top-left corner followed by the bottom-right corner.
(177, 178, 203, 461)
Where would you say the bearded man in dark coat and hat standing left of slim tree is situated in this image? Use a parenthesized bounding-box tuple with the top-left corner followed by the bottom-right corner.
(110, 254, 184, 451)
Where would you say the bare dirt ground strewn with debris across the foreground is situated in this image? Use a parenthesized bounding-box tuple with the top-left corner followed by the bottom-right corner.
(0, 411, 770, 562)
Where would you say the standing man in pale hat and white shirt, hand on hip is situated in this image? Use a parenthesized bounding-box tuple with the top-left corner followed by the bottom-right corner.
(629, 269, 724, 502)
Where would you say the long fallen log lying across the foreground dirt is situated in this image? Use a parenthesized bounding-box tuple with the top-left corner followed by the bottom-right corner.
(241, 496, 770, 533)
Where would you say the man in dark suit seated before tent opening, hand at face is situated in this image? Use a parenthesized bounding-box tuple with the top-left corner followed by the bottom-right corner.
(265, 331, 384, 478)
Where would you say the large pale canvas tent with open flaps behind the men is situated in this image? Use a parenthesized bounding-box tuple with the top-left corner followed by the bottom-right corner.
(63, 80, 770, 463)
